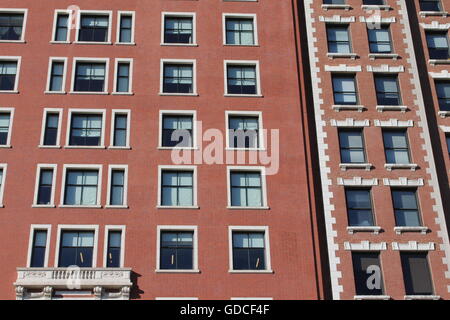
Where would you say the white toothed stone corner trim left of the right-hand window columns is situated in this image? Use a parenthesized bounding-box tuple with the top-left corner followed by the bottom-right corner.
(304, 0, 344, 300)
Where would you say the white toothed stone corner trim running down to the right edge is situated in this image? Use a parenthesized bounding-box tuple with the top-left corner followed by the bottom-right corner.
(397, 0, 450, 292)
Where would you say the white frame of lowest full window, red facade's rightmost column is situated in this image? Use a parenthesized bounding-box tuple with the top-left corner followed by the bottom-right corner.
(228, 226, 273, 273)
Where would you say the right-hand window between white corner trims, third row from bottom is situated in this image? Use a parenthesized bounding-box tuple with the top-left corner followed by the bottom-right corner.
(383, 130, 410, 164)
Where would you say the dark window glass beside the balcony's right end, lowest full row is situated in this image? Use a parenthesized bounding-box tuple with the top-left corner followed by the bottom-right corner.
(160, 232, 194, 270)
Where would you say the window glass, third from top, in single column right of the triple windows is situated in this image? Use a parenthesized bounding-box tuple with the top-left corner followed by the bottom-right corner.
(162, 116, 193, 147)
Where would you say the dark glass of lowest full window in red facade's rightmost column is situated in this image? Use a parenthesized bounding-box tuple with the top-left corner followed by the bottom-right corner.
(233, 232, 266, 270)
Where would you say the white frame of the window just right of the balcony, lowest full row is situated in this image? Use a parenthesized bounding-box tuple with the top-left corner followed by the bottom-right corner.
(155, 225, 200, 273)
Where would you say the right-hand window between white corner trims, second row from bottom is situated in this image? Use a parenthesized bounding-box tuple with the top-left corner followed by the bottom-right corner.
(392, 189, 422, 227)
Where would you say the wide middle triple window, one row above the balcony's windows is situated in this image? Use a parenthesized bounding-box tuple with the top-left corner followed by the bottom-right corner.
(64, 169, 100, 206)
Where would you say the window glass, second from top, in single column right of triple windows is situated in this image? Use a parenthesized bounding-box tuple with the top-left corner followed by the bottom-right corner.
(163, 64, 193, 93)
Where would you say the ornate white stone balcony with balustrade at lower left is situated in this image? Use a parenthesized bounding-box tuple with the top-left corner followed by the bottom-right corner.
(14, 267, 132, 300)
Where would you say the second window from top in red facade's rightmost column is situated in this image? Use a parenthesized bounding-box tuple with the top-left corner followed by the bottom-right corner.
(225, 62, 260, 95)
